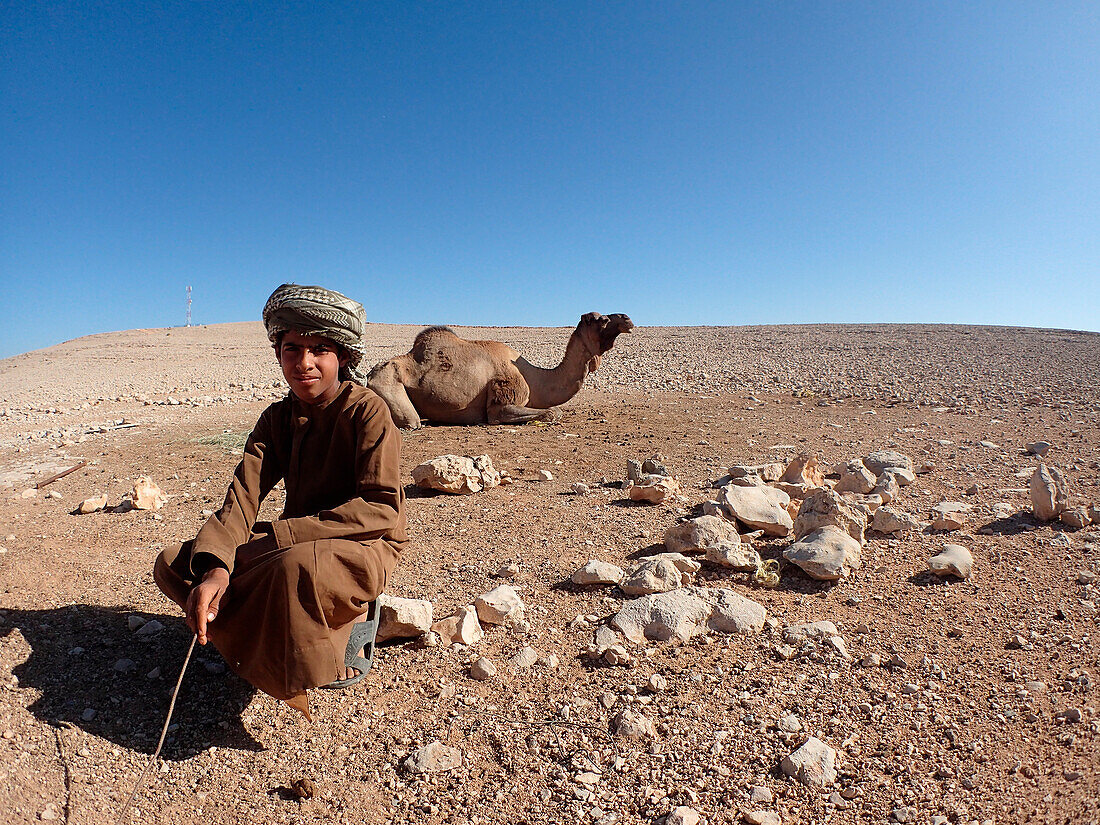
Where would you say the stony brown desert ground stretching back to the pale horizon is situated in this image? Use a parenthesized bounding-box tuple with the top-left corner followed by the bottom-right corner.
(0, 323, 1100, 825)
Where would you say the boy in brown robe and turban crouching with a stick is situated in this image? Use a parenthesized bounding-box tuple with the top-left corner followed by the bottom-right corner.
(153, 284, 408, 716)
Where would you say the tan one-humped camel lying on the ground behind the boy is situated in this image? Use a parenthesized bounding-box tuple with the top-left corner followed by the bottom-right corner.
(366, 312, 634, 429)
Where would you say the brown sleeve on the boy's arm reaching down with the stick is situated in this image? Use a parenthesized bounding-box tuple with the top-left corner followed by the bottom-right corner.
(191, 407, 279, 575)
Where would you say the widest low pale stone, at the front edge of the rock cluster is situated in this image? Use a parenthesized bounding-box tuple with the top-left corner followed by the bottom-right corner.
(611, 587, 767, 645)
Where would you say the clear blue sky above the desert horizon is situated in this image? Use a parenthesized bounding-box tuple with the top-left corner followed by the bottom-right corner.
(0, 1, 1100, 356)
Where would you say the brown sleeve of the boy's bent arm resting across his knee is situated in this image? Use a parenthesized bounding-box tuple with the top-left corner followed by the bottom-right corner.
(272, 398, 408, 549)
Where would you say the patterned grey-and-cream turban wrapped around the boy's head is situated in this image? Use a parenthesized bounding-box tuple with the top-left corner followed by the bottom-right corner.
(264, 284, 366, 384)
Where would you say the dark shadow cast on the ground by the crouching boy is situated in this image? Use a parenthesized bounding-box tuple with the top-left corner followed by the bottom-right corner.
(0, 604, 263, 759)
